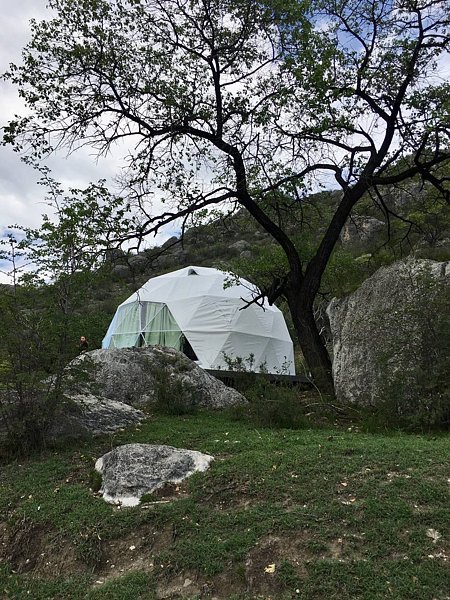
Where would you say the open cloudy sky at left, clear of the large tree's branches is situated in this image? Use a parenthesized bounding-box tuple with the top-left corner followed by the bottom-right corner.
(0, 0, 174, 283)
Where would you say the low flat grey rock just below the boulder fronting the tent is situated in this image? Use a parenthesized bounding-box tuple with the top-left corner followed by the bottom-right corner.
(51, 394, 145, 437)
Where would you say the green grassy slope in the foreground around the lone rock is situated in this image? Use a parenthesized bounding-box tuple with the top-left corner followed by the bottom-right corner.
(0, 412, 450, 600)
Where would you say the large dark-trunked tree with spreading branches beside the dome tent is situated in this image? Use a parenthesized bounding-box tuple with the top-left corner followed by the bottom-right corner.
(5, 0, 450, 391)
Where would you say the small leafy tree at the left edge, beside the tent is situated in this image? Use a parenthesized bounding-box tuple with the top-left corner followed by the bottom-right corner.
(0, 169, 130, 452)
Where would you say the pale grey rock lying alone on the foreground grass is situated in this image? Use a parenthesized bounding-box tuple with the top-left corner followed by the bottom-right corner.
(95, 444, 213, 506)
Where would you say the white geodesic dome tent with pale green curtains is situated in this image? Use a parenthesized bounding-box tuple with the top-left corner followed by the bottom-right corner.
(102, 267, 295, 375)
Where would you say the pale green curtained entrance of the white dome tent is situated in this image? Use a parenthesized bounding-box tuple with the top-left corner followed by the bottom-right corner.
(108, 302, 197, 360)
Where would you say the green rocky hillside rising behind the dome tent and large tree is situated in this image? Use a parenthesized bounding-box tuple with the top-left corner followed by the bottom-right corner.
(109, 182, 450, 293)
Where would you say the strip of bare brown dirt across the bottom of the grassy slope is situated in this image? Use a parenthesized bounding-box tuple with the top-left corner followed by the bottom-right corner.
(0, 516, 366, 600)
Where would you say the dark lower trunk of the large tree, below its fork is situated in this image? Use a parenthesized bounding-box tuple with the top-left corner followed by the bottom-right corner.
(289, 296, 334, 396)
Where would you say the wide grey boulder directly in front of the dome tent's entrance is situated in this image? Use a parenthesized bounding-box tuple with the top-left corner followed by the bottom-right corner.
(72, 346, 247, 409)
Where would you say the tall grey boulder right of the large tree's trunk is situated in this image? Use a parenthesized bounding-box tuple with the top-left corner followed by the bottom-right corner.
(327, 259, 450, 412)
